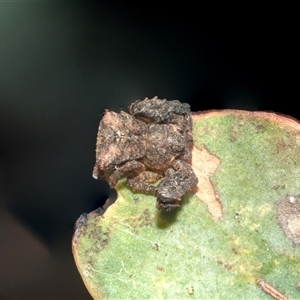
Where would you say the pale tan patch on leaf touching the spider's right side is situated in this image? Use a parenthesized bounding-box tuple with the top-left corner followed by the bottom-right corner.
(192, 146, 223, 219)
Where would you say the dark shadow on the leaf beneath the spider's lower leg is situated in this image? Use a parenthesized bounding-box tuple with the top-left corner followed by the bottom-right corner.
(155, 192, 193, 229)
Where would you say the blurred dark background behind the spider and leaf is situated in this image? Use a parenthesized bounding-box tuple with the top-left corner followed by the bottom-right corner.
(0, 1, 300, 299)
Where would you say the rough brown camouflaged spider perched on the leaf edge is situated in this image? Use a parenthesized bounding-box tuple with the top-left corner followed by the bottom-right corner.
(93, 97, 198, 211)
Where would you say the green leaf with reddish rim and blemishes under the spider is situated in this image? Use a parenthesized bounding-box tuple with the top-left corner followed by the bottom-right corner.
(72, 110, 300, 299)
